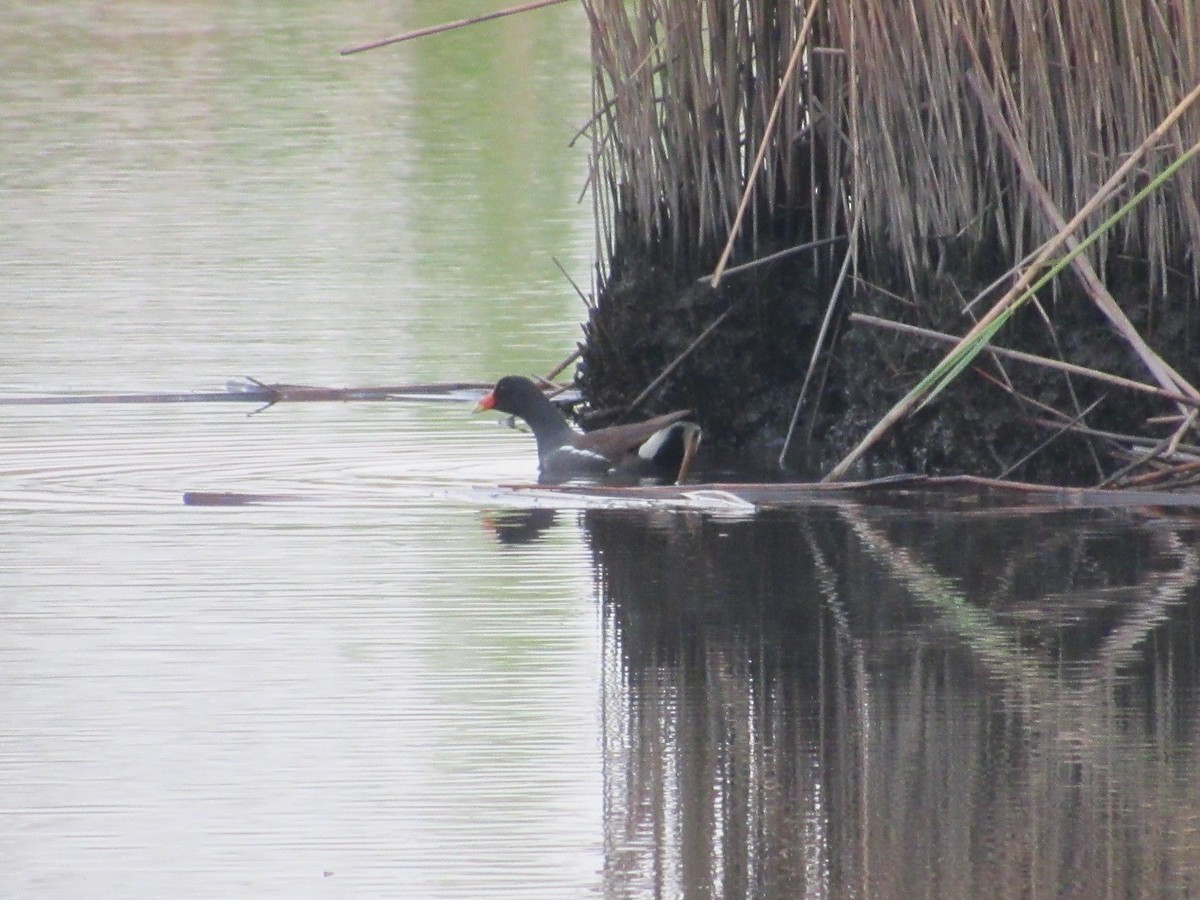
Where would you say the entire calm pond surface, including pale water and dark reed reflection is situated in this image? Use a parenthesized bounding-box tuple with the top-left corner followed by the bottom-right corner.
(0, 2, 1200, 898)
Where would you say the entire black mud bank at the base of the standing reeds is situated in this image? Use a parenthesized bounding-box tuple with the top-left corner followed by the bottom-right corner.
(578, 247, 1198, 485)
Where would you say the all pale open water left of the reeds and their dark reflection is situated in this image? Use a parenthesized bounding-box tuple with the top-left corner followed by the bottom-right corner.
(0, 0, 602, 898)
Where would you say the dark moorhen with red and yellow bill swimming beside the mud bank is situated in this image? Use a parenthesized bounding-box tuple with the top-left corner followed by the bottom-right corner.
(475, 376, 700, 484)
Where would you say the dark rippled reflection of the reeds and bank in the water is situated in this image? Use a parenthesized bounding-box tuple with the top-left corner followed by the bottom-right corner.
(586, 506, 1200, 896)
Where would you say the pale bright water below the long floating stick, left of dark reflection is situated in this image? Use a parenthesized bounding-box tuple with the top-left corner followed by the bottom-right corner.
(0, 404, 601, 896)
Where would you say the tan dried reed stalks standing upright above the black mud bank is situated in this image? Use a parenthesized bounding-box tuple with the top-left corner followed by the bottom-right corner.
(584, 0, 1200, 292)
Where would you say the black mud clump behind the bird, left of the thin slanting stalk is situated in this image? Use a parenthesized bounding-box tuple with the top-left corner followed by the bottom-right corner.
(578, 240, 822, 480)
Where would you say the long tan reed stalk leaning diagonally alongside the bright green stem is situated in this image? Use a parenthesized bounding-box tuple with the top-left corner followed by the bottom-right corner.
(823, 85, 1200, 481)
